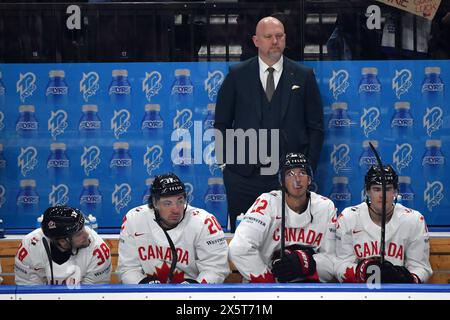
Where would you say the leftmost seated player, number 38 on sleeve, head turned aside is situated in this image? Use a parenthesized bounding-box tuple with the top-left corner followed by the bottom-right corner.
(14, 206, 111, 285)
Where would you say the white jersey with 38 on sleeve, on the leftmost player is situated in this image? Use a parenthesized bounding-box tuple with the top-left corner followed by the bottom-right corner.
(14, 228, 111, 285)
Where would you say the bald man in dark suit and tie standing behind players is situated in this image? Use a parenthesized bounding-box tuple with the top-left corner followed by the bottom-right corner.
(214, 17, 324, 232)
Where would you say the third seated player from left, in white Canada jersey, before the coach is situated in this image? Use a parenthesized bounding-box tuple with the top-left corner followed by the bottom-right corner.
(230, 153, 336, 282)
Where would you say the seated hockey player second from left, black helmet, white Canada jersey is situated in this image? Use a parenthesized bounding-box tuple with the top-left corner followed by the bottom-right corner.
(117, 173, 230, 284)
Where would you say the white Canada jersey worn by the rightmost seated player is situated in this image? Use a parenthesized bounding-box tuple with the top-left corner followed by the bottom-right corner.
(335, 202, 433, 282)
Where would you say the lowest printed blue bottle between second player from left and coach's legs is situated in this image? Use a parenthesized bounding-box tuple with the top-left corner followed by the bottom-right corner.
(205, 178, 228, 227)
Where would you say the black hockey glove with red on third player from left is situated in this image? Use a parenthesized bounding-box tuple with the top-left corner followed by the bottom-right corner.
(272, 248, 316, 282)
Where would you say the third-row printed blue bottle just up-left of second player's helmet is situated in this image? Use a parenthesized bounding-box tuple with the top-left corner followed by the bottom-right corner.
(109, 142, 133, 183)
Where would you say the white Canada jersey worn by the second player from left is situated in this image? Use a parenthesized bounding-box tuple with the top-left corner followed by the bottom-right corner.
(117, 205, 230, 284)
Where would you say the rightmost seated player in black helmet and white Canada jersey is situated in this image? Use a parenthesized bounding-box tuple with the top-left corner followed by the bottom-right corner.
(335, 166, 433, 283)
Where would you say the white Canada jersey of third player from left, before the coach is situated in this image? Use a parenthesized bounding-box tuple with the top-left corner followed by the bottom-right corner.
(230, 190, 336, 282)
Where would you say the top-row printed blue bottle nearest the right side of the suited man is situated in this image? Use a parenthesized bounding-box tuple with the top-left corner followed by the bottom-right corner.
(359, 67, 381, 108)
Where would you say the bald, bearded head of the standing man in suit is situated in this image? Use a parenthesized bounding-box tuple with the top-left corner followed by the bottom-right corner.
(253, 17, 286, 66)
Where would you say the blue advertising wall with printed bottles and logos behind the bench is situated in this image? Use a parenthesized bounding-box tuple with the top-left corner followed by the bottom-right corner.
(0, 61, 450, 228)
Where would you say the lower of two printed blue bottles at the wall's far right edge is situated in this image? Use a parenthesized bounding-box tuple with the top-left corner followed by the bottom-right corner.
(422, 140, 445, 181)
